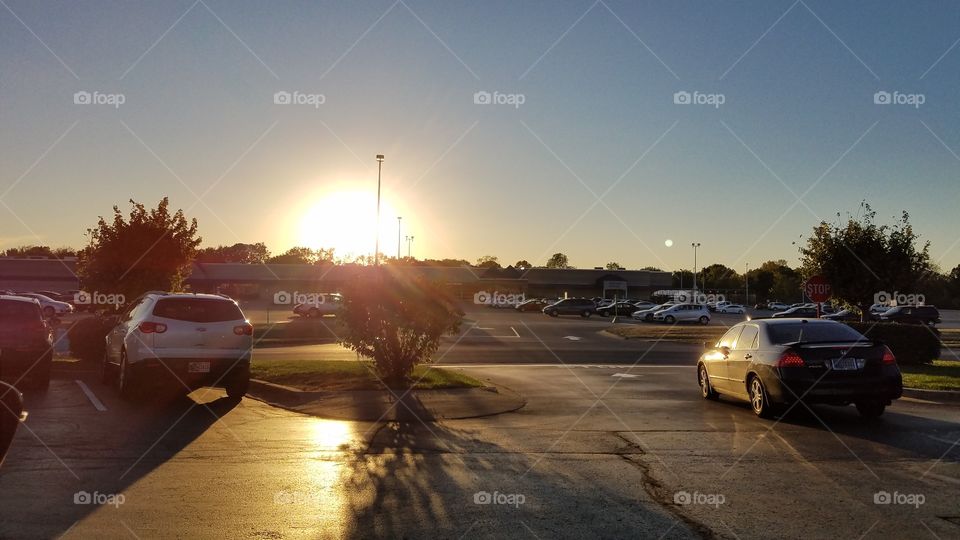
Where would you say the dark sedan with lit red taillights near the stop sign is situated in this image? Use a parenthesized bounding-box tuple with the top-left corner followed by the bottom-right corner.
(697, 319, 903, 418)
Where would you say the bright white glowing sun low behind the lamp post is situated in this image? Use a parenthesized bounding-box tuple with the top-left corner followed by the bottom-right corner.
(297, 190, 397, 257)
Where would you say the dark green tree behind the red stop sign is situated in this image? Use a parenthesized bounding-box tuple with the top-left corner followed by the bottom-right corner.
(800, 202, 931, 313)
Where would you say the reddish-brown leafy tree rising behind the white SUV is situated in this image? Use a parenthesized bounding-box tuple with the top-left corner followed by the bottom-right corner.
(77, 197, 201, 301)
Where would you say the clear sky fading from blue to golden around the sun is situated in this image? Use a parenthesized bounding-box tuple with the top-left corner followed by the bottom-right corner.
(0, 0, 960, 270)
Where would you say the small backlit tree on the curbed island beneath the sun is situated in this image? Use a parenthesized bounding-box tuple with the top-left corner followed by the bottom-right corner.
(337, 268, 463, 386)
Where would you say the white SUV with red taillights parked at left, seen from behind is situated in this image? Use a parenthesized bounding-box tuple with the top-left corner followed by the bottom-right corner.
(101, 292, 253, 398)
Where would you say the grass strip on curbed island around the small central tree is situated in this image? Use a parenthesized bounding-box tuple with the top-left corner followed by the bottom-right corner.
(250, 360, 487, 391)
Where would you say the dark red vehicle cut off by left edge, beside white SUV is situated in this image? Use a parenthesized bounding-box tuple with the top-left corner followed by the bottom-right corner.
(0, 295, 53, 391)
